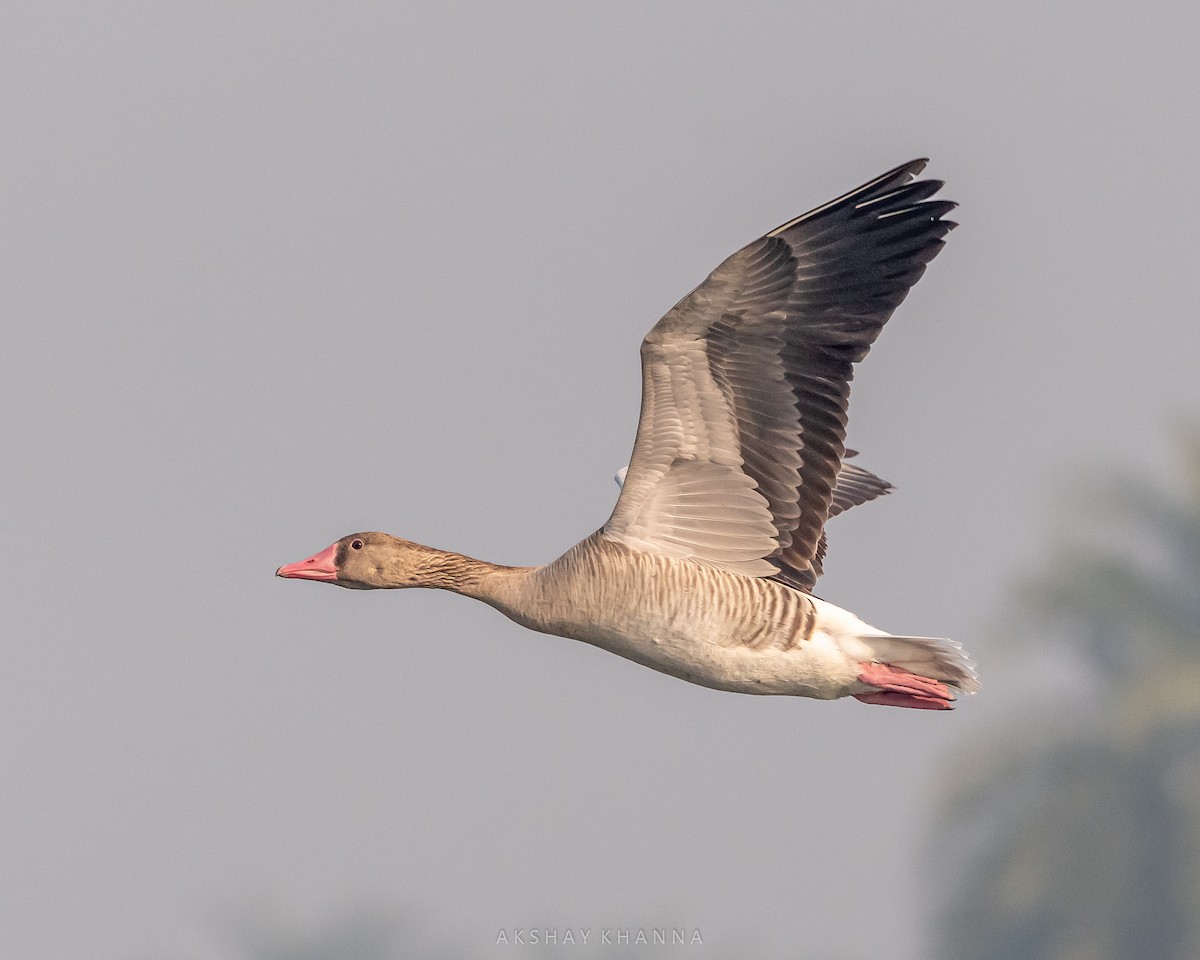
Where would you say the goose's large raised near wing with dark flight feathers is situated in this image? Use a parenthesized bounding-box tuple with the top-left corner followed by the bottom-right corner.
(602, 160, 954, 589)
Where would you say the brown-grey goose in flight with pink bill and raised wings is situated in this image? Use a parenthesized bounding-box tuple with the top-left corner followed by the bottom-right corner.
(276, 160, 979, 710)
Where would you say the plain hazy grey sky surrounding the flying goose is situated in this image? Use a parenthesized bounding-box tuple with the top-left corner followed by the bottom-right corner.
(0, 0, 1200, 960)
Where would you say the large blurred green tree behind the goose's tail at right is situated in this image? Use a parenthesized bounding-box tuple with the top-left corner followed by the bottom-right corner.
(937, 430, 1200, 960)
